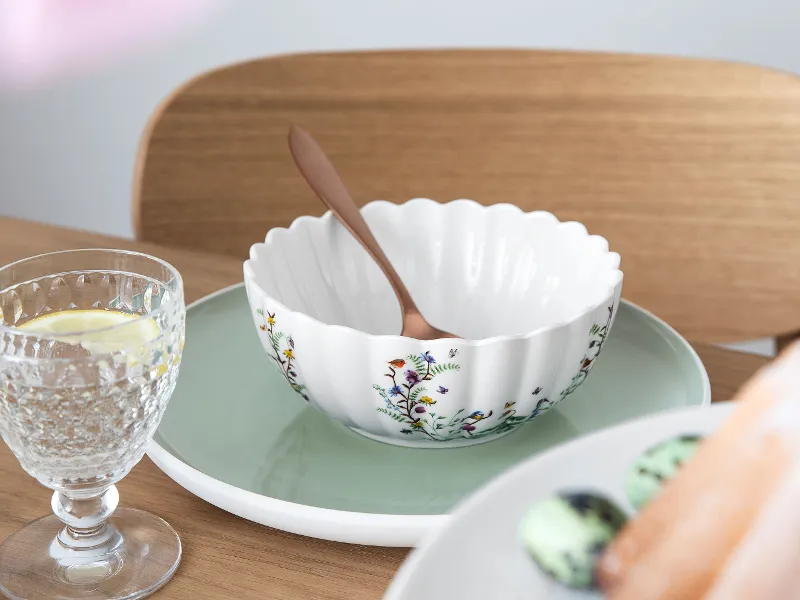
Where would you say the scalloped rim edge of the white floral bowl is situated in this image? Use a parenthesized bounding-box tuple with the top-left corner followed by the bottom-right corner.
(243, 198, 624, 347)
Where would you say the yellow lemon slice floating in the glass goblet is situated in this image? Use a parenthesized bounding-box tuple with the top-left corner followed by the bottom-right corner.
(18, 309, 161, 354)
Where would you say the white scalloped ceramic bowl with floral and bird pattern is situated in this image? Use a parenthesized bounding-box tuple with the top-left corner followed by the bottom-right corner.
(244, 199, 622, 447)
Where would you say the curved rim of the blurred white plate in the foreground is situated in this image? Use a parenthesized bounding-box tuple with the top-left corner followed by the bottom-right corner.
(382, 400, 735, 600)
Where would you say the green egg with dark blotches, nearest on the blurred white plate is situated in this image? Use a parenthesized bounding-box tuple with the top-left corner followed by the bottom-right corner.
(520, 492, 626, 589)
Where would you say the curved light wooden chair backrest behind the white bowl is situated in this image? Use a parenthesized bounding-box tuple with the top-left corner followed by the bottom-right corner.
(133, 50, 800, 341)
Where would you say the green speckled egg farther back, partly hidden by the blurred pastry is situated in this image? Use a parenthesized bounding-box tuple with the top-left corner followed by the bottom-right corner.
(625, 435, 702, 510)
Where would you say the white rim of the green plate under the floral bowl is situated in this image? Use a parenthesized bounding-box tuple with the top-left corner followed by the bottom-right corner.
(146, 282, 711, 548)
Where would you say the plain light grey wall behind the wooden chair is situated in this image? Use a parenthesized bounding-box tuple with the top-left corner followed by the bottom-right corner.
(0, 0, 788, 354)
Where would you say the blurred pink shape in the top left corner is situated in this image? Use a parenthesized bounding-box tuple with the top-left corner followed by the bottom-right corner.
(0, 0, 221, 87)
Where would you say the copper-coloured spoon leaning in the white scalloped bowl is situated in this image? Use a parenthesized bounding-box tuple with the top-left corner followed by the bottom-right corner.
(289, 125, 458, 340)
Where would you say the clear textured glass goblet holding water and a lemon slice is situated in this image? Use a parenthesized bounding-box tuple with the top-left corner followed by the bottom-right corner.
(0, 250, 186, 600)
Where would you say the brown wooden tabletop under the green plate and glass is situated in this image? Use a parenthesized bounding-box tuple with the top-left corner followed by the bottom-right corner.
(0, 218, 767, 600)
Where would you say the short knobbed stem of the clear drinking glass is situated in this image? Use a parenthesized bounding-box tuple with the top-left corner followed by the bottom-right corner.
(51, 485, 119, 550)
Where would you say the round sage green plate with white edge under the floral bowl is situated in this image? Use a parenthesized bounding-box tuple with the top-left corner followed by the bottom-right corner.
(148, 285, 711, 546)
